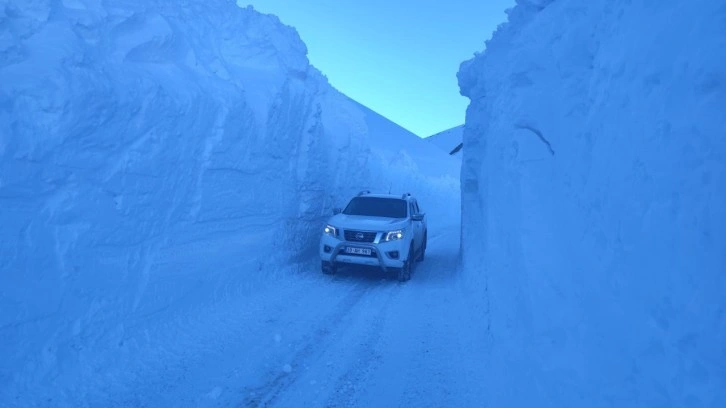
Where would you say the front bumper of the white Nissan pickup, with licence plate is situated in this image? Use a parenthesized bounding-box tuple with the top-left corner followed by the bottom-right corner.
(319, 235, 408, 272)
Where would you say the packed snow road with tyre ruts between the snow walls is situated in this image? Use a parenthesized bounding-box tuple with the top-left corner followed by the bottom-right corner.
(92, 225, 486, 407)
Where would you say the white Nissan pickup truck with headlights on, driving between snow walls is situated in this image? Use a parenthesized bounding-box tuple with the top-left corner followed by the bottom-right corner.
(320, 191, 428, 282)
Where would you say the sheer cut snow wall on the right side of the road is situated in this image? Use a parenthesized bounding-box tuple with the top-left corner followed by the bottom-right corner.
(458, 0, 726, 407)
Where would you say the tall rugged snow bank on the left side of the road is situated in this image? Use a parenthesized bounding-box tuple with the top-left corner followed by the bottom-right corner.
(0, 0, 458, 406)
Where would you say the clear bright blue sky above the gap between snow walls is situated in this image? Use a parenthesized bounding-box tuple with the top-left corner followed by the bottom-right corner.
(238, 0, 514, 137)
